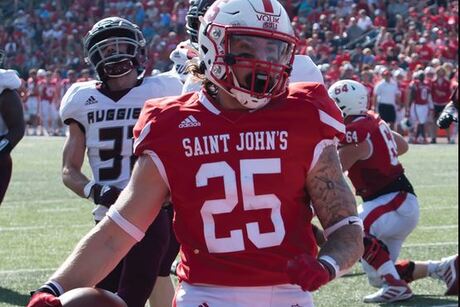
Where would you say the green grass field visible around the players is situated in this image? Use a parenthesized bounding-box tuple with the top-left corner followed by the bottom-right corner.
(0, 137, 458, 307)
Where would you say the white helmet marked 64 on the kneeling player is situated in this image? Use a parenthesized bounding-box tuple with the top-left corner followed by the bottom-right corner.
(328, 80, 368, 117)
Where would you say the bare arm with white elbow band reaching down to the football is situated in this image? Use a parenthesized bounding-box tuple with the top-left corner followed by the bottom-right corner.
(51, 156, 168, 291)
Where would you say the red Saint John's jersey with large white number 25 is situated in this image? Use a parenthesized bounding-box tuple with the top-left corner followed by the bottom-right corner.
(134, 83, 345, 286)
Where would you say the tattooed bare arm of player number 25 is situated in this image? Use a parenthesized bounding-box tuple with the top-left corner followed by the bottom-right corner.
(306, 146, 364, 270)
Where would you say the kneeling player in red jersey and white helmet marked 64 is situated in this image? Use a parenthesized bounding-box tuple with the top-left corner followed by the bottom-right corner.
(329, 80, 419, 303)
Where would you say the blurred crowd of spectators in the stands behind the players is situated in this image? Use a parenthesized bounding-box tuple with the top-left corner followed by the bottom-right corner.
(0, 0, 458, 142)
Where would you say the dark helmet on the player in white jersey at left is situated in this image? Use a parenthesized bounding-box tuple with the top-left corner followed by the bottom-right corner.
(83, 17, 146, 80)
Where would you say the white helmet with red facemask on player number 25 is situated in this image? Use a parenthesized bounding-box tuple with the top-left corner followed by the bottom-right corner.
(198, 0, 297, 109)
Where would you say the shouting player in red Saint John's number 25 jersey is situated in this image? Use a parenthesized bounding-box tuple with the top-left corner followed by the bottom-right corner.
(29, 0, 363, 307)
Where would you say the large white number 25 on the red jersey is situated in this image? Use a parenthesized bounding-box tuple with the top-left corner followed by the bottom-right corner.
(196, 159, 286, 253)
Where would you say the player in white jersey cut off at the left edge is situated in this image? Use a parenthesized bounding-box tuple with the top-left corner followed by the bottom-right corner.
(0, 49, 25, 205)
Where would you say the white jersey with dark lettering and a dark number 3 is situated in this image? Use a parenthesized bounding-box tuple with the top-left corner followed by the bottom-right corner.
(60, 76, 182, 188)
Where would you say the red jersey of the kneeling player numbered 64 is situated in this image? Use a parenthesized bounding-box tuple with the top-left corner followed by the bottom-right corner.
(342, 111, 404, 198)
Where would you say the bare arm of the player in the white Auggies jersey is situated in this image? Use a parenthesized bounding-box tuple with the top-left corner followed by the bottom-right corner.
(62, 122, 89, 197)
